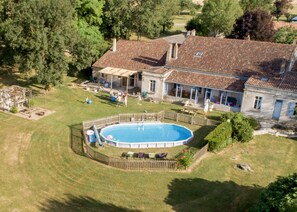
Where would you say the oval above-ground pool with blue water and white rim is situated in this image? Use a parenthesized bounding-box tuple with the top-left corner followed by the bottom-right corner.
(100, 122, 193, 148)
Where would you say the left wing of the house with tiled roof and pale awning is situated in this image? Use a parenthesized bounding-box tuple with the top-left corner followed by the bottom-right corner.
(92, 39, 170, 90)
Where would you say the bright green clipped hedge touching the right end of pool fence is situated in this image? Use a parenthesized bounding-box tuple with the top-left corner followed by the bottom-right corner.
(204, 121, 232, 151)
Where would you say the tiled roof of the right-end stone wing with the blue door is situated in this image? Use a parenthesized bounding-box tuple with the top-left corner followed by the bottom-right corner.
(246, 71, 297, 91)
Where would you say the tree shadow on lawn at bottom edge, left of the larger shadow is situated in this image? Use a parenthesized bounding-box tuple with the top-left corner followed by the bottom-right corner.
(39, 194, 139, 212)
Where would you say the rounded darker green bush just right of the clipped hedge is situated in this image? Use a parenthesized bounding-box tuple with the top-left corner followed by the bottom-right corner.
(231, 113, 253, 142)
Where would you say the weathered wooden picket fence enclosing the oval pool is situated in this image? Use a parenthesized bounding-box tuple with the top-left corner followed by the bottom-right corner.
(71, 111, 219, 171)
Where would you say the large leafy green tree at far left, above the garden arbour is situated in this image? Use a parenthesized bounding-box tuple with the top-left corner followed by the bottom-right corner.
(4, 0, 74, 88)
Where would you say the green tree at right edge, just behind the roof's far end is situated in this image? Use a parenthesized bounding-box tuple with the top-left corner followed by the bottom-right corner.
(273, 26, 297, 44)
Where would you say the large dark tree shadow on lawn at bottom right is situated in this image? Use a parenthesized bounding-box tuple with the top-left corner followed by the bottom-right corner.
(165, 178, 263, 212)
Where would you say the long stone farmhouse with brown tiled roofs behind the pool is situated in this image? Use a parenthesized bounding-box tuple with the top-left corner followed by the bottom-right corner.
(93, 35, 297, 120)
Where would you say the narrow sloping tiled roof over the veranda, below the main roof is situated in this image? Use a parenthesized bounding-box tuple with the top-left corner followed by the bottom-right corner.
(166, 70, 245, 92)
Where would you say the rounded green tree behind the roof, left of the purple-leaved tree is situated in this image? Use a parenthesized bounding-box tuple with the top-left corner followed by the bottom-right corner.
(201, 0, 242, 37)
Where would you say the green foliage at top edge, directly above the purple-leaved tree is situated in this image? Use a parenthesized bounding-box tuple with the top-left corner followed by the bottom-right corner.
(239, 0, 273, 12)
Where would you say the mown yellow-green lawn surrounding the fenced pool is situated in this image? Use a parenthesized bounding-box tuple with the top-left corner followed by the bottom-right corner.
(0, 76, 297, 211)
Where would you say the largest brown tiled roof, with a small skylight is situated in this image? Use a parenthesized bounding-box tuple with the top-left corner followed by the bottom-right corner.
(168, 36, 296, 76)
